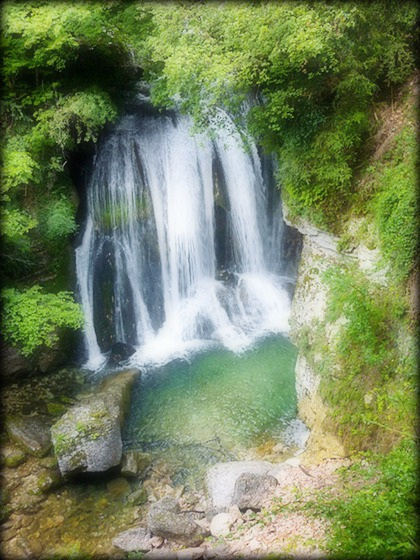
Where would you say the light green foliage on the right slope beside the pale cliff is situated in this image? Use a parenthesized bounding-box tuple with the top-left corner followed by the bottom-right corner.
(306, 264, 416, 452)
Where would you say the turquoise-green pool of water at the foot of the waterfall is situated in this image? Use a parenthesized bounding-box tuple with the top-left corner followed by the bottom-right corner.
(124, 336, 296, 483)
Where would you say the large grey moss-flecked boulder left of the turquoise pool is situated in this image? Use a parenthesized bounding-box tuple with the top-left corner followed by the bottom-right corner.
(51, 370, 139, 476)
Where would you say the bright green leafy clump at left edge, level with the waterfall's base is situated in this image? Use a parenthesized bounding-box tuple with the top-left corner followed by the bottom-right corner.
(2, 286, 83, 356)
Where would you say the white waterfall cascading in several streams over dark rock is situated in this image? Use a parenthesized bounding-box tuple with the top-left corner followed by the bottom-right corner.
(76, 109, 290, 370)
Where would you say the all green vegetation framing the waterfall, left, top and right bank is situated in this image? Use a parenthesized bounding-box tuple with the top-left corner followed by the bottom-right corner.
(1, 0, 418, 557)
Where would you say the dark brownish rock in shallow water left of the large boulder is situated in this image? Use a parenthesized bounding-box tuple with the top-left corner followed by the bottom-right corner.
(6, 415, 51, 457)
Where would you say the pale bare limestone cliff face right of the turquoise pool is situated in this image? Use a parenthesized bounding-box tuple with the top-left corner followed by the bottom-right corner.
(283, 207, 385, 464)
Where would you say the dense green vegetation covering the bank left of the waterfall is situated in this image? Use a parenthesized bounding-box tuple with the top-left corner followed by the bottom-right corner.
(1, 2, 151, 354)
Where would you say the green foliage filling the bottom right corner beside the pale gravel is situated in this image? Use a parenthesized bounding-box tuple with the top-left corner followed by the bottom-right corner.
(308, 439, 419, 559)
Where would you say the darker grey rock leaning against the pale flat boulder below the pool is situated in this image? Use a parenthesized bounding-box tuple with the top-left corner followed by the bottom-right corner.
(232, 472, 278, 510)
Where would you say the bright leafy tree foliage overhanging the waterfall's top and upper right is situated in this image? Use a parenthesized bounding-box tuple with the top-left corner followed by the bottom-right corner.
(141, 2, 417, 227)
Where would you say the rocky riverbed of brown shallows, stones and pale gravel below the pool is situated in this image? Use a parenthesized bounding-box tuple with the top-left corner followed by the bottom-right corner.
(1, 370, 346, 560)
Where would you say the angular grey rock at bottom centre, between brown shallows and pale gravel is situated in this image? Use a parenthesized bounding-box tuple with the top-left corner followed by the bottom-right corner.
(148, 496, 210, 546)
